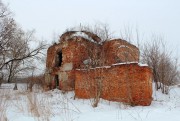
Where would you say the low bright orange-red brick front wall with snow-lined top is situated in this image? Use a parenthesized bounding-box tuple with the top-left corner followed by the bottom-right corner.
(75, 64, 152, 105)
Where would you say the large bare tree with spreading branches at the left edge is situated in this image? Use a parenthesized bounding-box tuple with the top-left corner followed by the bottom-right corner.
(0, 1, 46, 85)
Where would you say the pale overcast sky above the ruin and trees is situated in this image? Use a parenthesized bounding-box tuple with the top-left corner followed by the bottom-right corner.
(3, 0, 180, 55)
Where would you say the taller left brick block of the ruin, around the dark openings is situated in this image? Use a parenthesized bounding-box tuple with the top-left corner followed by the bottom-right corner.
(46, 37, 98, 90)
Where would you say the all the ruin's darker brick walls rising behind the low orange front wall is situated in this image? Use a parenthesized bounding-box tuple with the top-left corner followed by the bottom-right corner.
(45, 32, 142, 93)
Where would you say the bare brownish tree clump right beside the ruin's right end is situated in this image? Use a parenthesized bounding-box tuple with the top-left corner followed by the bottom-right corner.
(142, 36, 179, 94)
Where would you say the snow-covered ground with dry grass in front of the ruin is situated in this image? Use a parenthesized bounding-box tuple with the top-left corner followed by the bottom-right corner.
(0, 84, 180, 121)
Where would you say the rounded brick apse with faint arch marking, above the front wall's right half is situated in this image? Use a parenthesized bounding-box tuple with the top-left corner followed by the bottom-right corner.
(103, 39, 139, 65)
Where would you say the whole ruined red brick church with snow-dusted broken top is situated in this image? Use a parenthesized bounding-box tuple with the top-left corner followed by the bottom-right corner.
(45, 31, 152, 105)
